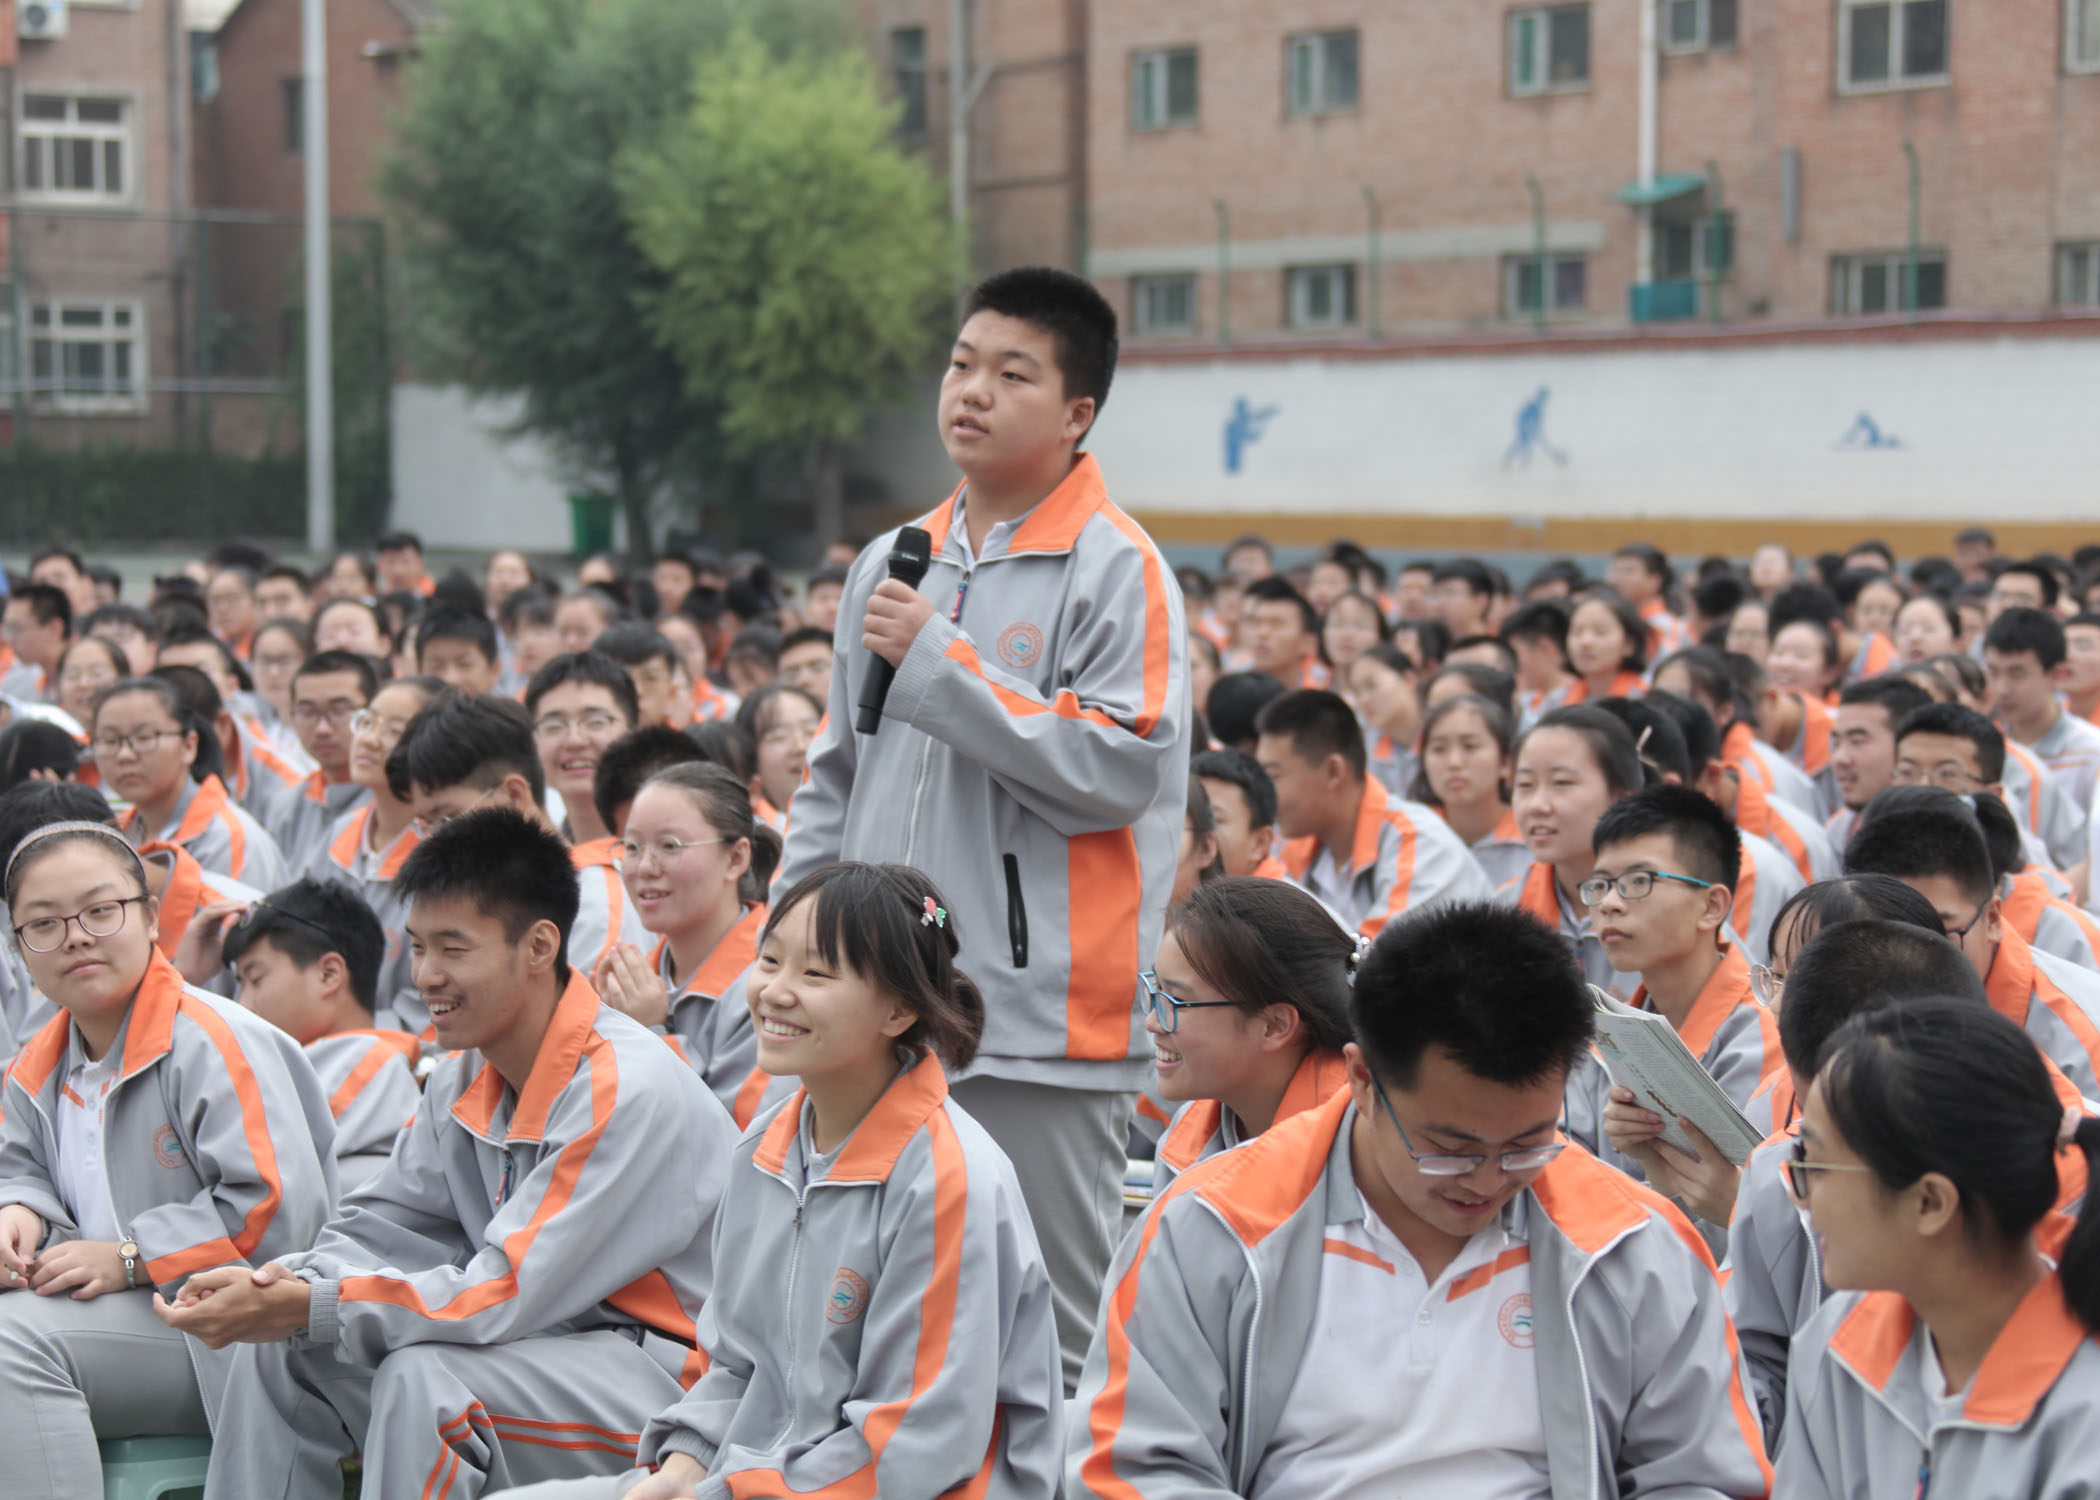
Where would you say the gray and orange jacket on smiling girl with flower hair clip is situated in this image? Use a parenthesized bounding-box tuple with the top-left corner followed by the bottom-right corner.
(641, 1057, 1065, 1500)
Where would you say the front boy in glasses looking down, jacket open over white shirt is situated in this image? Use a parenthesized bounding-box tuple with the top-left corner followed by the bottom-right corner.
(1067, 903, 1770, 1496)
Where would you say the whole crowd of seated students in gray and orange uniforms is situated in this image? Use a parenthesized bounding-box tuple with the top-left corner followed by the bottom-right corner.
(12, 428, 2100, 1500)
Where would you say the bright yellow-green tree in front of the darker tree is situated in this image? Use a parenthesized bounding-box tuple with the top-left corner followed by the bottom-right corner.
(617, 29, 953, 540)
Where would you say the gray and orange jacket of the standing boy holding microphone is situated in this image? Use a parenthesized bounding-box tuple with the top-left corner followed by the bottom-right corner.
(775, 456, 1189, 1090)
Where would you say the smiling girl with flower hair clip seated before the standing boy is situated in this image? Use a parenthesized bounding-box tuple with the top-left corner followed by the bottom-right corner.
(512, 857, 1065, 1500)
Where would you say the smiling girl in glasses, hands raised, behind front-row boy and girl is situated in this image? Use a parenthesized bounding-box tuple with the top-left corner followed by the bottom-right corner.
(592, 761, 785, 1126)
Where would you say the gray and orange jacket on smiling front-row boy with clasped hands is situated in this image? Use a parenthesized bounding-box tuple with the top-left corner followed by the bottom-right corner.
(284, 971, 735, 1384)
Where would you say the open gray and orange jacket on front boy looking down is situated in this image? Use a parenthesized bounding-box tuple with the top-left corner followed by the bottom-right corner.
(1065, 1090, 1772, 1500)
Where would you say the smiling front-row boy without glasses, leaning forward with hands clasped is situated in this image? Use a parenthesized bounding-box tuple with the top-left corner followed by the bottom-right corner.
(164, 809, 735, 1500)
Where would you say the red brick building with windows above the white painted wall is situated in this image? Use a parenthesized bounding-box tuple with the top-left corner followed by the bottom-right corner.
(1088, 0, 2100, 342)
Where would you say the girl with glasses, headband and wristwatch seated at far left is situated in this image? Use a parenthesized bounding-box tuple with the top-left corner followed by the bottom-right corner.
(0, 824, 336, 1500)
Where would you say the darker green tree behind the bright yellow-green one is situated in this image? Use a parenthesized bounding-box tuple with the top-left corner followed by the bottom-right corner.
(382, 0, 846, 550)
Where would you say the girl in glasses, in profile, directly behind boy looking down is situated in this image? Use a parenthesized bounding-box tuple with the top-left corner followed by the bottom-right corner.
(1138, 876, 1367, 1191)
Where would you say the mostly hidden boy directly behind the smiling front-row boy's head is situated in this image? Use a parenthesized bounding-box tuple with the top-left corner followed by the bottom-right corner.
(386, 693, 647, 975)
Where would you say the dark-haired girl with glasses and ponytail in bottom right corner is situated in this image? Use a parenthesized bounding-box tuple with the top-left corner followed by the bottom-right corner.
(1772, 1000, 2100, 1500)
